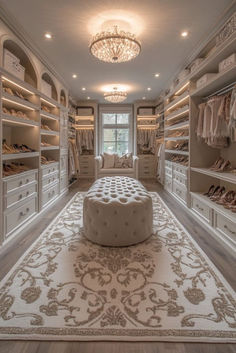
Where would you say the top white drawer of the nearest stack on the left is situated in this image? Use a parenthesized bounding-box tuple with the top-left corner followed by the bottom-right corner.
(3, 171, 38, 194)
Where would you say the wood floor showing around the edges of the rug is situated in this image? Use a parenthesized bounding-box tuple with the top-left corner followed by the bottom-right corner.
(0, 180, 236, 353)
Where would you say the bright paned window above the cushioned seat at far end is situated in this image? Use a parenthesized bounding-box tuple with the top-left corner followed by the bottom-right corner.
(101, 112, 131, 155)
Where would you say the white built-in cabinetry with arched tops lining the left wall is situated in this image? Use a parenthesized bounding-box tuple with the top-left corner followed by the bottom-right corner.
(0, 28, 68, 244)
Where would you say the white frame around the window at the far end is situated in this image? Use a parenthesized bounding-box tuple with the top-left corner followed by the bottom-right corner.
(99, 105, 134, 153)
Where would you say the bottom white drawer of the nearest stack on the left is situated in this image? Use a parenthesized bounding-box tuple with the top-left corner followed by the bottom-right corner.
(4, 197, 38, 237)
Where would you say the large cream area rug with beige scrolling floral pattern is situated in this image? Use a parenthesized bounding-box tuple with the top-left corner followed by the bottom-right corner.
(0, 193, 236, 342)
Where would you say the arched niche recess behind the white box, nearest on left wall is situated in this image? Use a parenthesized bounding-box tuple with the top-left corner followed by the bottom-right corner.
(3, 39, 38, 88)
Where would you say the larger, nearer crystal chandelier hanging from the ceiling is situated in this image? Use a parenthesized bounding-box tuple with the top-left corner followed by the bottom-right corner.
(89, 26, 141, 63)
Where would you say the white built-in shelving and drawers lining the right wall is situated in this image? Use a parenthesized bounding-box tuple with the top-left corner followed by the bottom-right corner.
(164, 15, 236, 251)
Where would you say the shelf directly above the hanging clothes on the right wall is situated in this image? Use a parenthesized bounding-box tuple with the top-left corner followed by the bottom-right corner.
(191, 65, 236, 97)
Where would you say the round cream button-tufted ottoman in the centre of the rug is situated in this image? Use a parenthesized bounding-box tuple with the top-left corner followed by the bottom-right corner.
(83, 176, 153, 246)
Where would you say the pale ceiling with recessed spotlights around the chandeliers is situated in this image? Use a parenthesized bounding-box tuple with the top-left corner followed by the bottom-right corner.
(0, 0, 233, 102)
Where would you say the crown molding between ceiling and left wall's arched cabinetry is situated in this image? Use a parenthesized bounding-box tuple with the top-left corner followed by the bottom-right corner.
(0, 5, 70, 90)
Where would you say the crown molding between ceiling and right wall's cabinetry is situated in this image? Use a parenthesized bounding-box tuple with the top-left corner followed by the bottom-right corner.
(157, 0, 236, 99)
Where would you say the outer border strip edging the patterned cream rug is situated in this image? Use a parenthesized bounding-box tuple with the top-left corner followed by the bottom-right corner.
(0, 191, 236, 344)
